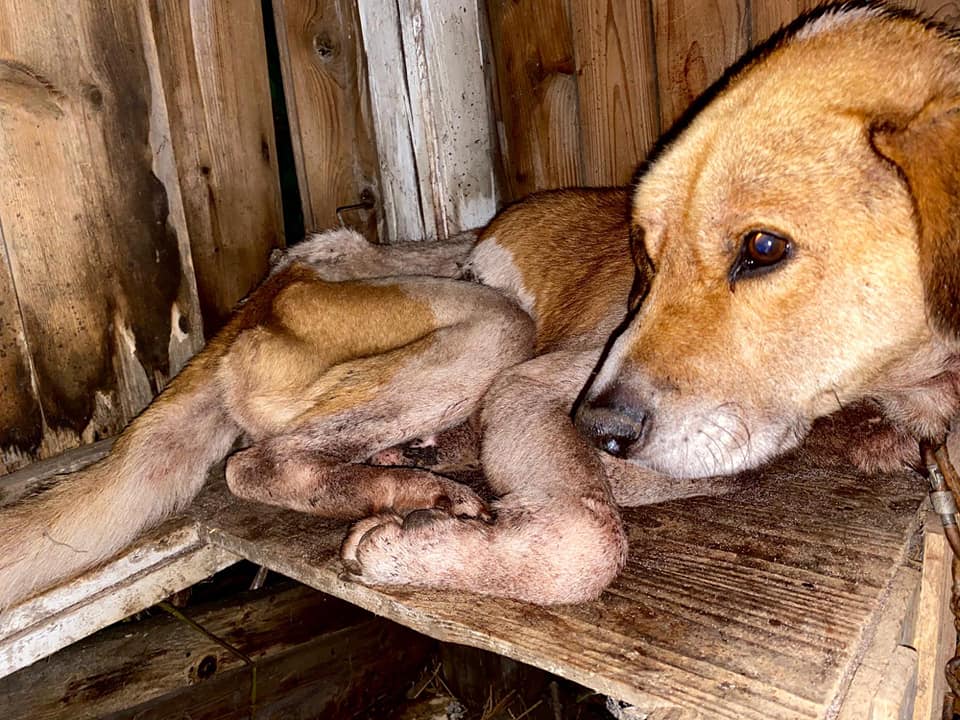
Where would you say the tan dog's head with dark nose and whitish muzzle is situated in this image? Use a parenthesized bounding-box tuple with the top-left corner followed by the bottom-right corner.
(577, 4, 960, 477)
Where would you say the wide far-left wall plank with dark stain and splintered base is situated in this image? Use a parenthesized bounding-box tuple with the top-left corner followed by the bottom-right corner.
(0, 0, 206, 457)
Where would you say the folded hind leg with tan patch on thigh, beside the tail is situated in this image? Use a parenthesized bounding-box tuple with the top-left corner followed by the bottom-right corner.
(223, 278, 533, 518)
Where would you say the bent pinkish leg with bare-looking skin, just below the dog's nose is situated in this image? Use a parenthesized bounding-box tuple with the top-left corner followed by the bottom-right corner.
(343, 353, 627, 604)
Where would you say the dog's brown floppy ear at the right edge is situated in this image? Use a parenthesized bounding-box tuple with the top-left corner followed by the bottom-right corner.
(871, 97, 960, 340)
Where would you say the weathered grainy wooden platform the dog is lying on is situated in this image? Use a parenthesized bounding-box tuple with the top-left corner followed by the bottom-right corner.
(0, 444, 924, 720)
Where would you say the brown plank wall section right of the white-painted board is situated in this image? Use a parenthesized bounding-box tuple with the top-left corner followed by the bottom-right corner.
(487, 0, 960, 200)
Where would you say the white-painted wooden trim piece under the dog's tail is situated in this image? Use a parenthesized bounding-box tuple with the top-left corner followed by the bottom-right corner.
(0, 518, 240, 677)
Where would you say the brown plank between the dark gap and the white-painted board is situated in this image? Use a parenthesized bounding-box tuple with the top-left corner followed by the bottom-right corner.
(273, 0, 380, 240)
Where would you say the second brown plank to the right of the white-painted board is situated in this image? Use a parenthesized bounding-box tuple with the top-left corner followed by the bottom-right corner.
(571, 0, 660, 185)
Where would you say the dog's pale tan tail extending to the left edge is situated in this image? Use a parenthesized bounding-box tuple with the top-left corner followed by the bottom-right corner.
(0, 344, 239, 609)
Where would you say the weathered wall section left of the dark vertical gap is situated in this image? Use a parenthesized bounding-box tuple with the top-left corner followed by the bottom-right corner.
(0, 0, 283, 470)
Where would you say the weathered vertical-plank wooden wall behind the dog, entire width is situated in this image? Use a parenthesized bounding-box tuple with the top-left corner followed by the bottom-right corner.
(0, 0, 960, 474)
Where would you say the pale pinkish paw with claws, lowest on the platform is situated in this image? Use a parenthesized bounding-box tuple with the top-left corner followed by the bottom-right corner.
(340, 509, 485, 587)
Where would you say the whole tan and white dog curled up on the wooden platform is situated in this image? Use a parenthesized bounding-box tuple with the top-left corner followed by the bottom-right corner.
(0, 2, 960, 606)
